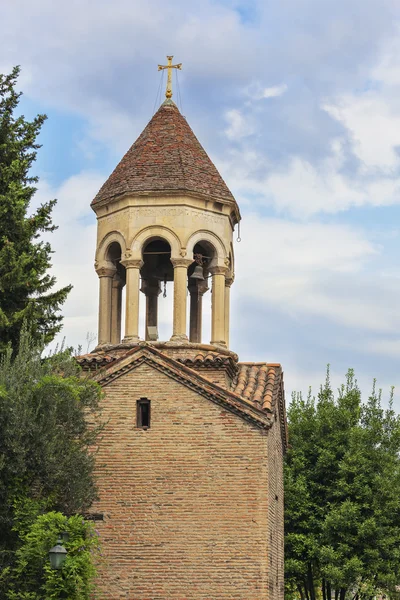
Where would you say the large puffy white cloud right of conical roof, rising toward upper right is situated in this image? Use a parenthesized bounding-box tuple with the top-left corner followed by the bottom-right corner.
(216, 24, 400, 219)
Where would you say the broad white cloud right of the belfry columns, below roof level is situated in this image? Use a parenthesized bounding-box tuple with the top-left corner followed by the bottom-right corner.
(235, 215, 400, 332)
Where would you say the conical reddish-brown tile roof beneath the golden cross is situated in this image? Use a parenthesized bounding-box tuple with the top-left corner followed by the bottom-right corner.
(92, 100, 236, 205)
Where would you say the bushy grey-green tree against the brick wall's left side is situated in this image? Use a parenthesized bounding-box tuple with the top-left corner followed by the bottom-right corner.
(0, 330, 101, 597)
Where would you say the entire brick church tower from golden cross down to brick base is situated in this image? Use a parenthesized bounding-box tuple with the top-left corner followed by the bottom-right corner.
(82, 56, 287, 600)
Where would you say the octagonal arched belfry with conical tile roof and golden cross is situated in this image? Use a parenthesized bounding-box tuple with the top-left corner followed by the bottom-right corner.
(92, 57, 240, 349)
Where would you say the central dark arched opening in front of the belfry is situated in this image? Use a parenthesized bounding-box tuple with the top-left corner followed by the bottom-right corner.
(140, 238, 174, 341)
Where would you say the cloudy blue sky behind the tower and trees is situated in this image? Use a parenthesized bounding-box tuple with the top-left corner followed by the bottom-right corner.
(0, 0, 400, 411)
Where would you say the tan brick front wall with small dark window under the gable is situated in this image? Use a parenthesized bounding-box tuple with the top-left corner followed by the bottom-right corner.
(93, 364, 274, 600)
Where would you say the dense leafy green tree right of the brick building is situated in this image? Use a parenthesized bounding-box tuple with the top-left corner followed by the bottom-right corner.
(285, 371, 400, 600)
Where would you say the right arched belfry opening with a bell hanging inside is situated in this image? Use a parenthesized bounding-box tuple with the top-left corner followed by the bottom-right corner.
(188, 240, 216, 343)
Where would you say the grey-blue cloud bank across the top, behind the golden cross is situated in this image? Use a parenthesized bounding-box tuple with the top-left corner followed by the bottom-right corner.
(0, 0, 396, 159)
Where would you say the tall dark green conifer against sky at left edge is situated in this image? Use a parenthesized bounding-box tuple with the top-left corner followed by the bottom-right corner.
(0, 67, 71, 354)
